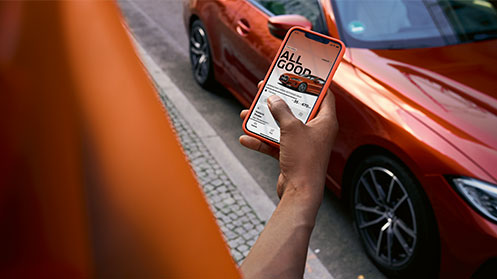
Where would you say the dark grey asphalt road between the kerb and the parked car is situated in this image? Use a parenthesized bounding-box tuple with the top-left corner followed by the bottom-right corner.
(119, 0, 385, 279)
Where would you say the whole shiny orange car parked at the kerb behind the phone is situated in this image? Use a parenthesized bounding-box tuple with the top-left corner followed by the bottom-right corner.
(184, 0, 497, 278)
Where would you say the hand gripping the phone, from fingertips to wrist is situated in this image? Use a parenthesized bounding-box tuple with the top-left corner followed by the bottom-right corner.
(240, 84, 338, 203)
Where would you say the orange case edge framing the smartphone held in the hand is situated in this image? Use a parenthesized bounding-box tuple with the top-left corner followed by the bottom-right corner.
(242, 26, 345, 148)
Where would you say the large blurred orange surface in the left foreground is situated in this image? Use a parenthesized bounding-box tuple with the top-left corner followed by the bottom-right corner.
(0, 1, 240, 278)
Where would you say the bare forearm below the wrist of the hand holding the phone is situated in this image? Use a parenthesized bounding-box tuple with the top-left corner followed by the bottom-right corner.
(241, 186, 322, 278)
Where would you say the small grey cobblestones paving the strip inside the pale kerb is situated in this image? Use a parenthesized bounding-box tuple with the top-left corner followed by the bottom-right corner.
(157, 85, 264, 264)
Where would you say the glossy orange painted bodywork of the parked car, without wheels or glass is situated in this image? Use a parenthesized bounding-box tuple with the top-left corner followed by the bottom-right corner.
(184, 0, 497, 278)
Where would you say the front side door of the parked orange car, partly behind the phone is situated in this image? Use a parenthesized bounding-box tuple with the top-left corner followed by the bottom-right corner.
(231, 0, 334, 101)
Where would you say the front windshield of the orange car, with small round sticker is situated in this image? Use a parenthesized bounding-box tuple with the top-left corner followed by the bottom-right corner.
(331, 0, 497, 49)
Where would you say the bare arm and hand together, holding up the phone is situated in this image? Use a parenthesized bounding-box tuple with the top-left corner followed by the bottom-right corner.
(236, 92, 338, 278)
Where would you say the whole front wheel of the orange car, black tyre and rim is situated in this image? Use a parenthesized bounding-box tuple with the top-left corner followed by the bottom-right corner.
(350, 155, 440, 278)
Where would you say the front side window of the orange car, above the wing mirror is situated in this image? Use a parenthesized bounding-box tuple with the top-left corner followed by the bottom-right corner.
(251, 0, 328, 34)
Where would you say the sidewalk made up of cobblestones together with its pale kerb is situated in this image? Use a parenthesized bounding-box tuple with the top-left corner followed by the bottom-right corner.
(135, 41, 333, 279)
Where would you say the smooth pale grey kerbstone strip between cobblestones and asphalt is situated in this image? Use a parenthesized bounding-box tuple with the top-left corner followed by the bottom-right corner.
(134, 39, 333, 279)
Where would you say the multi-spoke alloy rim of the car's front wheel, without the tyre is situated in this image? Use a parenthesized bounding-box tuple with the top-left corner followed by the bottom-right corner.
(353, 167, 418, 267)
